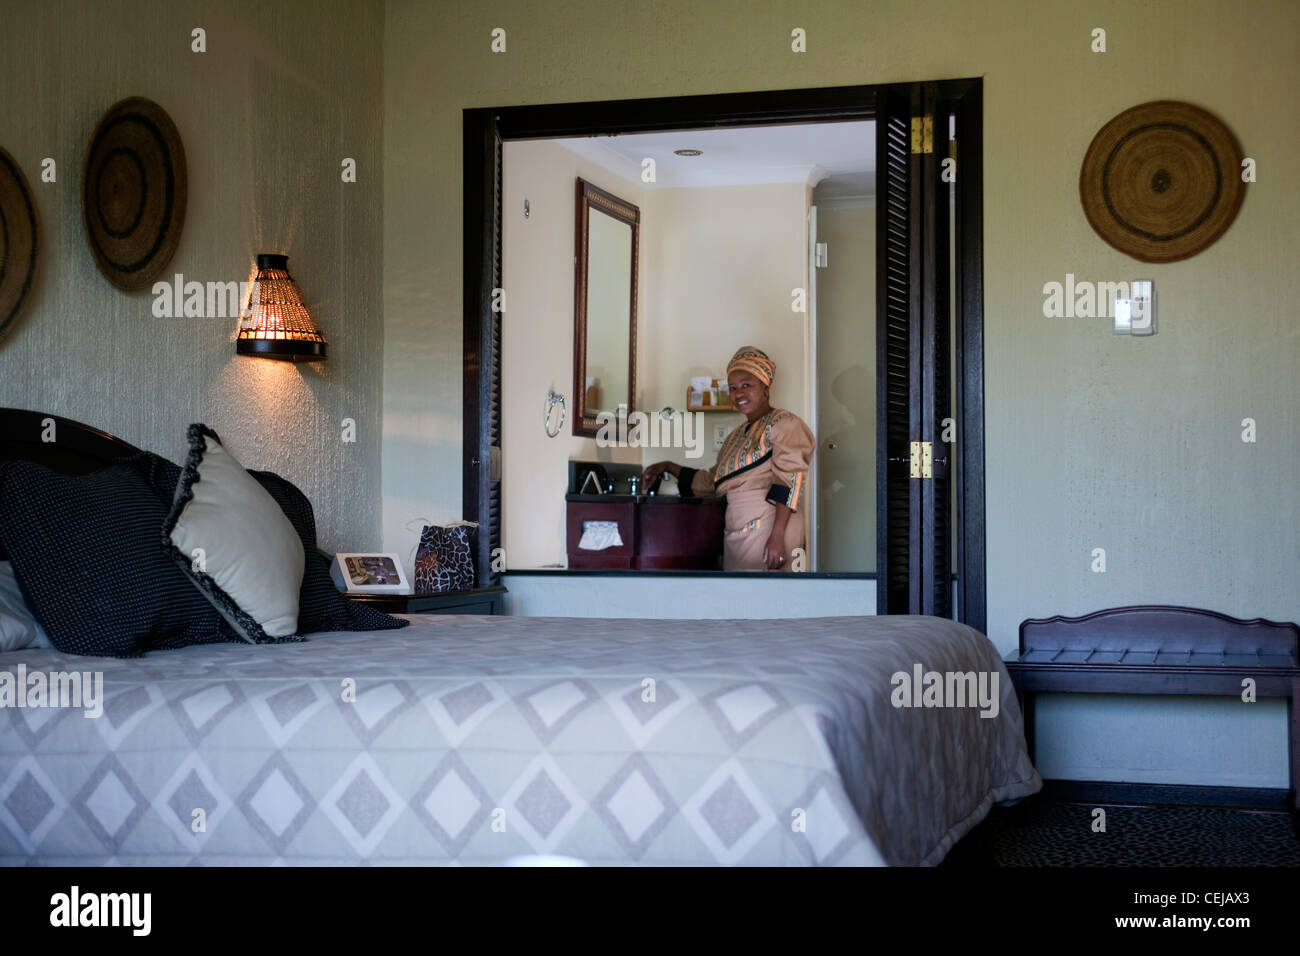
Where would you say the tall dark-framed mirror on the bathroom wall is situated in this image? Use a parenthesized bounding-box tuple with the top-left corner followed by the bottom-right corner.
(573, 178, 641, 437)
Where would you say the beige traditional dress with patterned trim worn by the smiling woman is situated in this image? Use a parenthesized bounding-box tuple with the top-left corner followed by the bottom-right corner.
(677, 408, 816, 571)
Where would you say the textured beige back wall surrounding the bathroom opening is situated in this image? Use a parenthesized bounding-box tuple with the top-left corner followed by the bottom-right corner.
(384, 0, 1300, 648)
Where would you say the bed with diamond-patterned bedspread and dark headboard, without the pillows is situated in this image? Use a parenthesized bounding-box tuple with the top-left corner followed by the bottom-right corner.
(0, 412, 1041, 865)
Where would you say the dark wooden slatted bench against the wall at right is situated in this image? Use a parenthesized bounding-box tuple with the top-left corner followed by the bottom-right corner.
(1006, 605, 1300, 831)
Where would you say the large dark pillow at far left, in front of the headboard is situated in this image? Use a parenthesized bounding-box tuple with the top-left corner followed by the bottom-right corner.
(0, 460, 237, 657)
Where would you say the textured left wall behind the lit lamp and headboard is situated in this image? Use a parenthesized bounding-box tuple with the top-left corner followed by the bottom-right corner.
(0, 0, 384, 549)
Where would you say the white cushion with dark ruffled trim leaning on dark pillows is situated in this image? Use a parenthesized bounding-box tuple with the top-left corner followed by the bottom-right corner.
(163, 425, 306, 644)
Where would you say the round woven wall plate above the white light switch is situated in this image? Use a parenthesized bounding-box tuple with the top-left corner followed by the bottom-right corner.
(1079, 100, 1245, 263)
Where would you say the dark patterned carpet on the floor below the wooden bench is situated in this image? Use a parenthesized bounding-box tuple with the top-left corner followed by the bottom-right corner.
(941, 799, 1300, 868)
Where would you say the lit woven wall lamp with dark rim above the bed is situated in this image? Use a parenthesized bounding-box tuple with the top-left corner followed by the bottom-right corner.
(235, 252, 325, 362)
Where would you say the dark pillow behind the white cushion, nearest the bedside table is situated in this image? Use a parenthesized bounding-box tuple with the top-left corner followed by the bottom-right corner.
(124, 451, 411, 640)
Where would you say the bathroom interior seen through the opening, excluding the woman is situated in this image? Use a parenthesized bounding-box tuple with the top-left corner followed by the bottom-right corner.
(502, 121, 876, 574)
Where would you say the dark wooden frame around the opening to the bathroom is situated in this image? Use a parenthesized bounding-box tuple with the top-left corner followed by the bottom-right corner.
(463, 78, 985, 631)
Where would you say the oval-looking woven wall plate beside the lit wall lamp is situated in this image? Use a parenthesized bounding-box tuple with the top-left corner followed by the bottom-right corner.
(82, 96, 187, 291)
